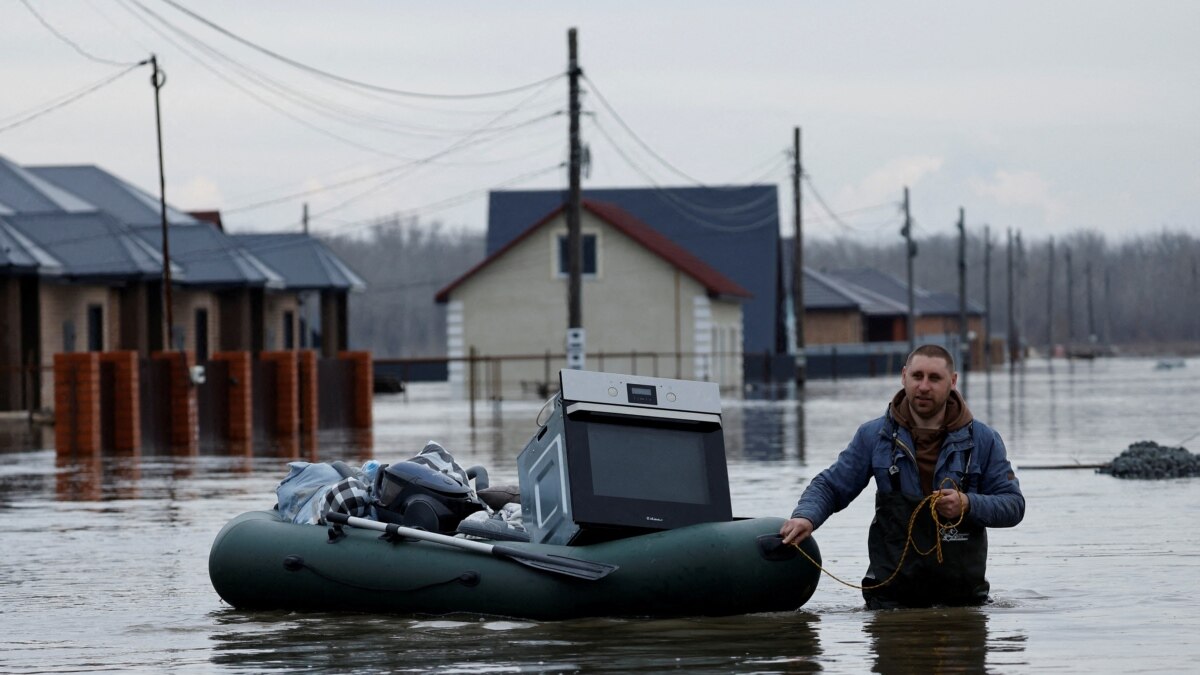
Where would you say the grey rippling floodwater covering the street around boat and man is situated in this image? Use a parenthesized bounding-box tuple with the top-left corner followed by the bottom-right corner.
(0, 359, 1200, 673)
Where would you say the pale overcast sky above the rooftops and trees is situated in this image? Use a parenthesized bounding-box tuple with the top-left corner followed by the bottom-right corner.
(0, 0, 1200, 240)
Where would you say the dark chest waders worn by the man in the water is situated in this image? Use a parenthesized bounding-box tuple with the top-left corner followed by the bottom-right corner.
(863, 427, 990, 609)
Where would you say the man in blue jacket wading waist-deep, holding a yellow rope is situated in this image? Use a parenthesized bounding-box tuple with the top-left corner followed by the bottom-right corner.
(779, 345, 1025, 609)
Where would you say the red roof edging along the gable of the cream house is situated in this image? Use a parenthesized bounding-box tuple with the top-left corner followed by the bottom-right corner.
(436, 199, 750, 303)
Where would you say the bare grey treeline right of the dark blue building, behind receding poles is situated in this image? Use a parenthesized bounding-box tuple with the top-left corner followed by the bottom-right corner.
(804, 229, 1200, 351)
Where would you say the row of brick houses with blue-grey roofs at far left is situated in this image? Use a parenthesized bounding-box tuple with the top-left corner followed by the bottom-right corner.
(0, 157, 364, 411)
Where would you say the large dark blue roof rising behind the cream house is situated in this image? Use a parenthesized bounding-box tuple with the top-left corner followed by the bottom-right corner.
(487, 185, 782, 352)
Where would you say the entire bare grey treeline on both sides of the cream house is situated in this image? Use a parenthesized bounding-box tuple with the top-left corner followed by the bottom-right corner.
(326, 219, 1200, 358)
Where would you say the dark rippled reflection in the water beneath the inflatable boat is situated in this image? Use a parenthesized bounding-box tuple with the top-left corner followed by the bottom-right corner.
(212, 610, 822, 673)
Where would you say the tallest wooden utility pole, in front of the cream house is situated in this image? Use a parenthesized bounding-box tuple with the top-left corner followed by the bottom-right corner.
(566, 28, 587, 370)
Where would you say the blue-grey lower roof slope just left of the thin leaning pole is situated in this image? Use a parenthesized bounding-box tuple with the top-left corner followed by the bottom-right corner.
(4, 211, 177, 281)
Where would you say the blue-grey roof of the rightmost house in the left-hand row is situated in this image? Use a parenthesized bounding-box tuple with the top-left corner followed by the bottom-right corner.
(229, 232, 367, 291)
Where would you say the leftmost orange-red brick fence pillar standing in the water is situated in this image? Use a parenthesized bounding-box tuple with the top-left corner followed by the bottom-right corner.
(54, 352, 101, 453)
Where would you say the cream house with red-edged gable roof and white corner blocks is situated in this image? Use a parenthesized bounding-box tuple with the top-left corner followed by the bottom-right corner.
(436, 197, 751, 395)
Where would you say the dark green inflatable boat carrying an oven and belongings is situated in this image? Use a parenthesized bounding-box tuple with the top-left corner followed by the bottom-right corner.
(209, 512, 821, 620)
